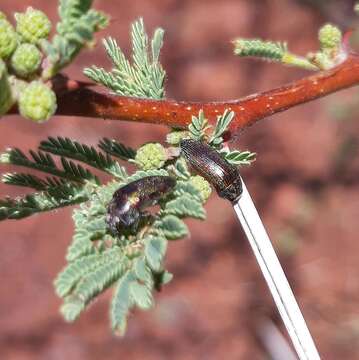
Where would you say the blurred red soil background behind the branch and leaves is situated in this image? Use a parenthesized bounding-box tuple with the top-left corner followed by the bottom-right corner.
(0, 0, 359, 360)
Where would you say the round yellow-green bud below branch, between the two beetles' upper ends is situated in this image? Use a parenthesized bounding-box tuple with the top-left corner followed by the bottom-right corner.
(135, 143, 167, 170)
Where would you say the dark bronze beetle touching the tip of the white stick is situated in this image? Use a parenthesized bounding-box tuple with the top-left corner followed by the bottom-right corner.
(180, 139, 242, 202)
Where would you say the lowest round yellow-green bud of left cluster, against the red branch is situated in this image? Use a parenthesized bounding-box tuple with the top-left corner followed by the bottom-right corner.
(19, 81, 57, 123)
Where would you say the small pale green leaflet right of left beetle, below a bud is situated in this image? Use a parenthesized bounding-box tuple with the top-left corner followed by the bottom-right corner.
(164, 195, 206, 220)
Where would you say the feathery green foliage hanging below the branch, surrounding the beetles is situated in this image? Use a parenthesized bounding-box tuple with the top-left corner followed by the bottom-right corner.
(0, 104, 258, 334)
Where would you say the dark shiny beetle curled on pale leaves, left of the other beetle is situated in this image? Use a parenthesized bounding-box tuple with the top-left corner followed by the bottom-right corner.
(106, 176, 176, 234)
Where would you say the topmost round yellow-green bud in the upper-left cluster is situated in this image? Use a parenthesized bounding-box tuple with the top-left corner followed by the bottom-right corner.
(15, 7, 51, 44)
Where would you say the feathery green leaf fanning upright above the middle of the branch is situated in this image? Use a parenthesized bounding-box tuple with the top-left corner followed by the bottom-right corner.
(84, 19, 165, 99)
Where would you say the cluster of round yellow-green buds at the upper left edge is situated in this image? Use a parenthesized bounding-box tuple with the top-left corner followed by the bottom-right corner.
(0, 7, 57, 122)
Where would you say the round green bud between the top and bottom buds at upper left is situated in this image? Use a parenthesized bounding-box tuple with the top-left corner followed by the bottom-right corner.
(11, 44, 42, 78)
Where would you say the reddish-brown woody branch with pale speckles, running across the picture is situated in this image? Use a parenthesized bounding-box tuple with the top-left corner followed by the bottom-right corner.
(9, 54, 359, 133)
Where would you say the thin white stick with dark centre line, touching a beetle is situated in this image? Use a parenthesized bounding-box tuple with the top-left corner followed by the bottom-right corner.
(233, 179, 320, 360)
